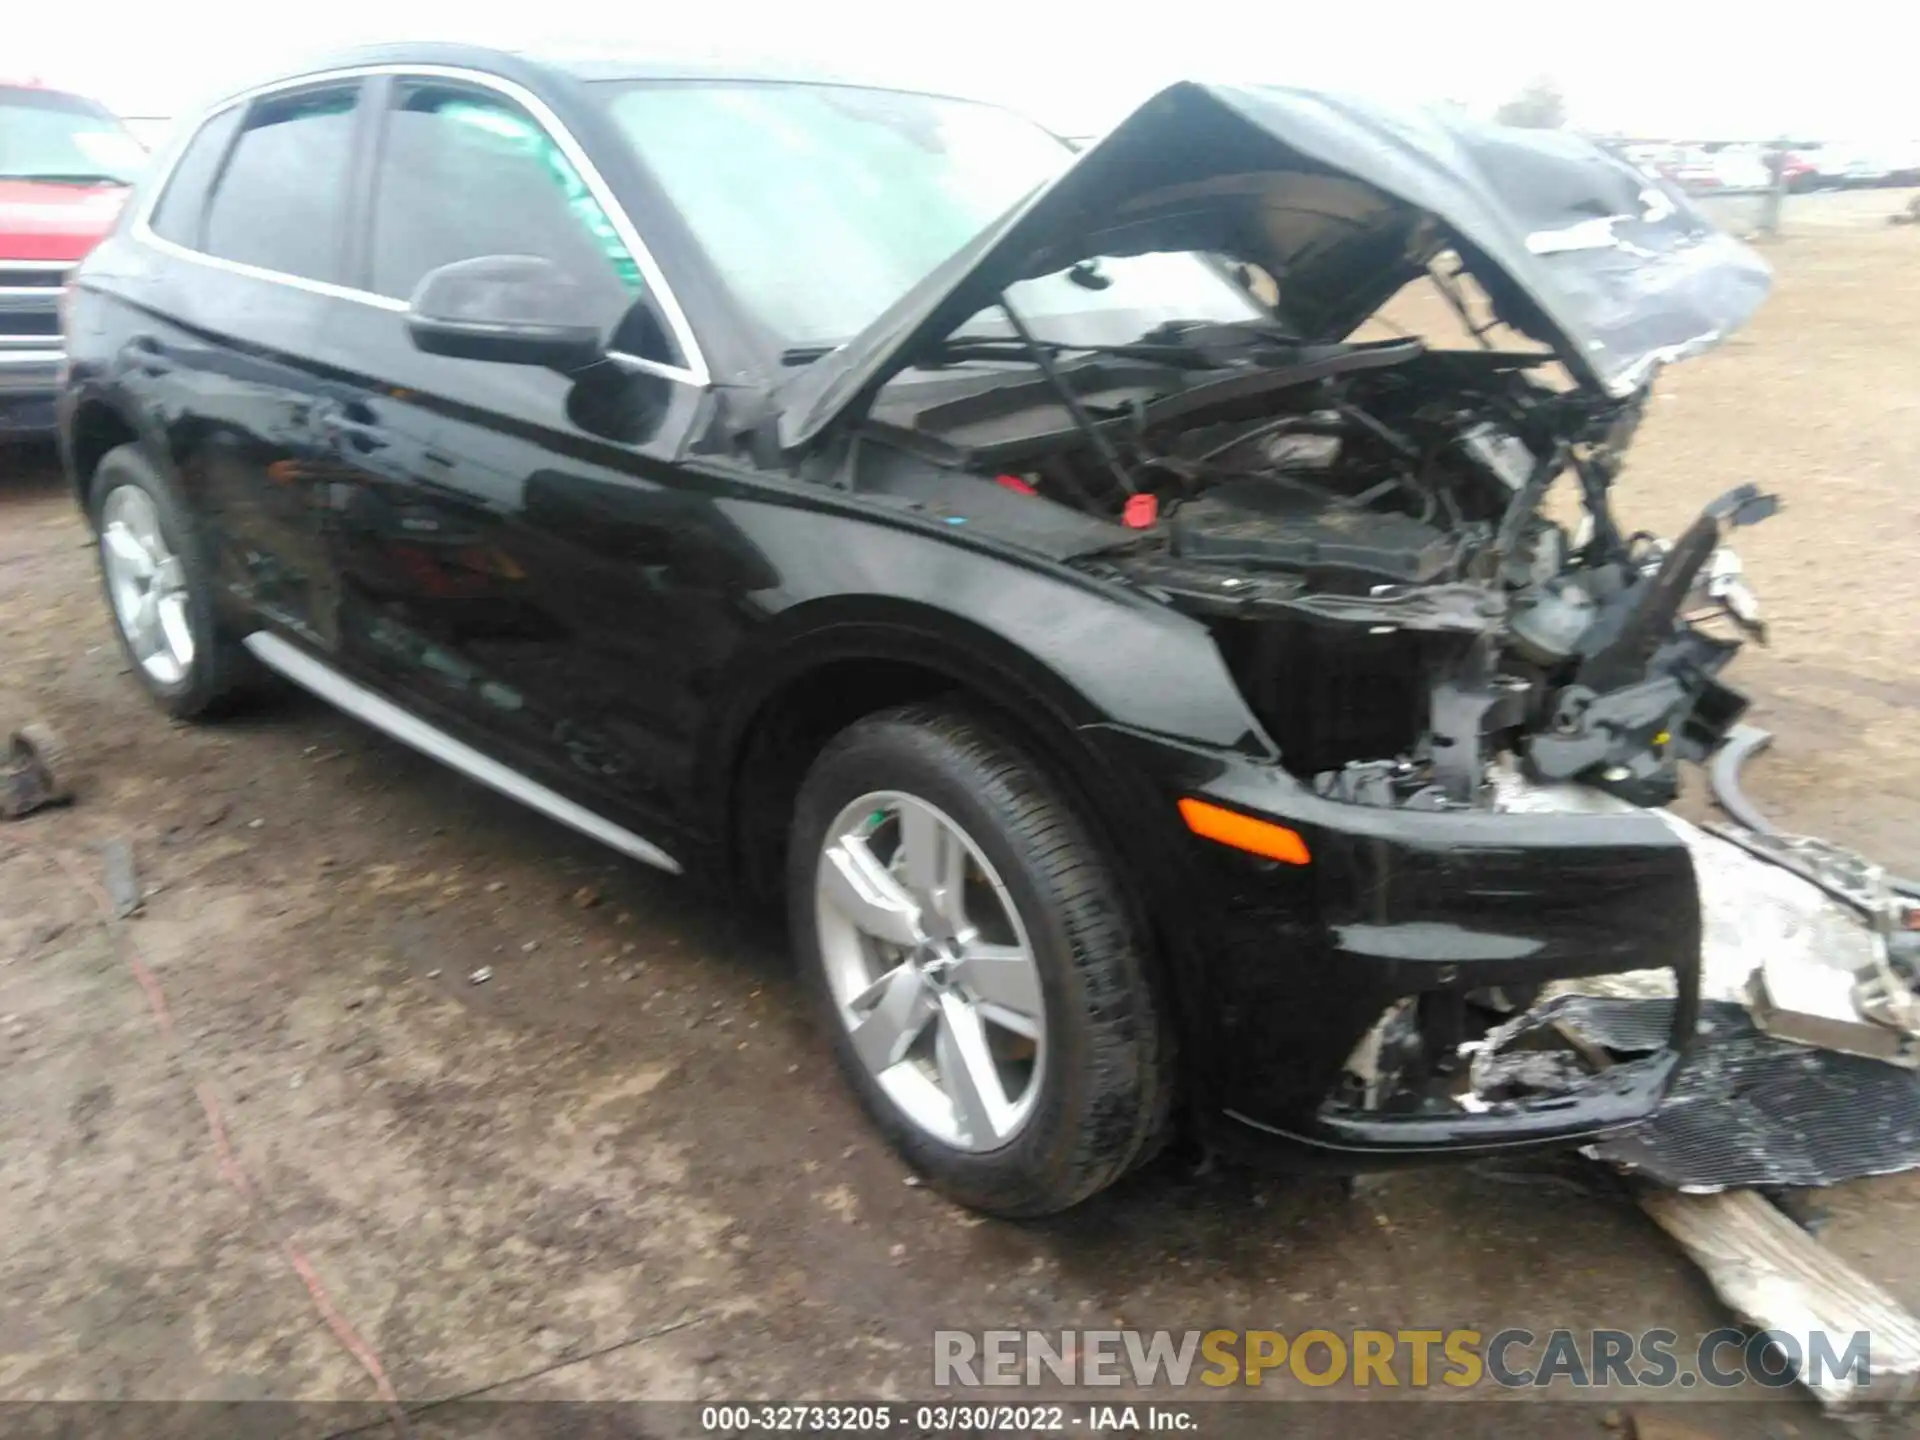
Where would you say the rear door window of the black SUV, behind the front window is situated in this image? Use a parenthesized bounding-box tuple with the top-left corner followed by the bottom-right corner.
(200, 83, 359, 280)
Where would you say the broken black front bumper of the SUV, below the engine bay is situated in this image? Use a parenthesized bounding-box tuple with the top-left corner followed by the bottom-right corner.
(1090, 733, 1701, 1169)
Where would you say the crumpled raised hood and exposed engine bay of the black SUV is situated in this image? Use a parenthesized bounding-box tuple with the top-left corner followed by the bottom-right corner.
(780, 84, 1774, 810)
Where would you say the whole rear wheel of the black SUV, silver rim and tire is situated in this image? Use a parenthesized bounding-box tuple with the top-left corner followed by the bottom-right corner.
(90, 445, 250, 720)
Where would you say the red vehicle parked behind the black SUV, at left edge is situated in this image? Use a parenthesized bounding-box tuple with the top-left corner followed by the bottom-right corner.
(0, 81, 146, 440)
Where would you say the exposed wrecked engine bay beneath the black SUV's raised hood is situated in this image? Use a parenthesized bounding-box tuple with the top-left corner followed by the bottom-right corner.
(848, 326, 1776, 808)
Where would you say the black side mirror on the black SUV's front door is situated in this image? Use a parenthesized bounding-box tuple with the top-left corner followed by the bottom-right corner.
(407, 255, 605, 371)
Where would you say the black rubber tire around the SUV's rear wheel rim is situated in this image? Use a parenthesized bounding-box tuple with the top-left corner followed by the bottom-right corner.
(86, 445, 257, 720)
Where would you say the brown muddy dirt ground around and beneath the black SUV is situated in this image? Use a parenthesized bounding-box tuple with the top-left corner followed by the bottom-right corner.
(0, 192, 1920, 1436)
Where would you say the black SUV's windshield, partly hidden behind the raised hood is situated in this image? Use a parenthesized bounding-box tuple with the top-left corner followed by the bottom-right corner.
(609, 81, 1260, 349)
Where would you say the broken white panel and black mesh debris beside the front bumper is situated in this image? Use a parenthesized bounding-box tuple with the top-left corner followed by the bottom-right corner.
(1476, 748, 1920, 1192)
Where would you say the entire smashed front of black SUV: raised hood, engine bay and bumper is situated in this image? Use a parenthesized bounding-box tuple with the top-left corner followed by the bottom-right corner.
(780, 76, 1778, 1164)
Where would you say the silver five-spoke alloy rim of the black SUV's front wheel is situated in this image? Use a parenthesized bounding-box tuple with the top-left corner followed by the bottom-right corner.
(814, 791, 1046, 1152)
